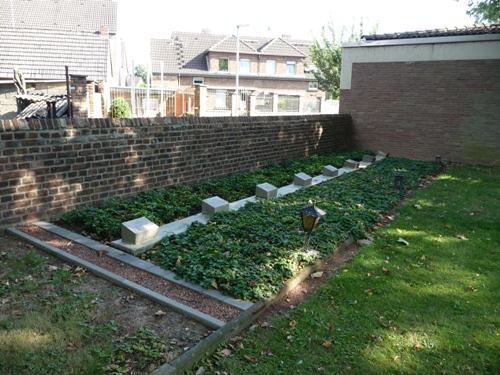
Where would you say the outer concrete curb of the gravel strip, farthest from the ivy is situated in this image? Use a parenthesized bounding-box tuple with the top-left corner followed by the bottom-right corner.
(7, 228, 226, 329)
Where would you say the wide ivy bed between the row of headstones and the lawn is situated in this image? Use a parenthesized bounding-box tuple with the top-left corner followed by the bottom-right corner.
(145, 158, 438, 300)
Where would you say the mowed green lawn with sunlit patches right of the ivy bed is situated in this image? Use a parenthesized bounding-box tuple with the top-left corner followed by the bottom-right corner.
(212, 167, 500, 374)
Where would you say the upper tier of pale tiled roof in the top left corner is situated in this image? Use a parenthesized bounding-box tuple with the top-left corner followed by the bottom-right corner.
(0, 0, 117, 34)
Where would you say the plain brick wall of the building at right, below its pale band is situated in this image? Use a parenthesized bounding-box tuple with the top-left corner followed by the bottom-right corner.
(340, 60, 500, 165)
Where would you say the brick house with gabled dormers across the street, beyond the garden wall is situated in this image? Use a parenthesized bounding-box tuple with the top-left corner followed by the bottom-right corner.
(151, 32, 325, 116)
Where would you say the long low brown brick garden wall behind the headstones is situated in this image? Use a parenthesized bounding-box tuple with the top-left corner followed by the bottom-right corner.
(0, 115, 351, 227)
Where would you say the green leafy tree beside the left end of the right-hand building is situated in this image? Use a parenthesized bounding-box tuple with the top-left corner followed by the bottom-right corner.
(311, 21, 376, 99)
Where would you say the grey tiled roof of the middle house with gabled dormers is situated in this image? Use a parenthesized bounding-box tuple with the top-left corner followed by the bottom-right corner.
(151, 32, 312, 74)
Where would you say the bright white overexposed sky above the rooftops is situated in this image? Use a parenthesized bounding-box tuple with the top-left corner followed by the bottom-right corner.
(118, 0, 474, 63)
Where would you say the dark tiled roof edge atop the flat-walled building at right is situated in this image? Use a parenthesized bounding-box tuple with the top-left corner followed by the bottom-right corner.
(363, 24, 500, 41)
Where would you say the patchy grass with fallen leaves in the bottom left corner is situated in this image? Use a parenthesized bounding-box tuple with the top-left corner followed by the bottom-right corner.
(0, 248, 170, 375)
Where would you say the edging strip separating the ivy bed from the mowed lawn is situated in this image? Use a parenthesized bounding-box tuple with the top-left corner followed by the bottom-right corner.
(152, 237, 354, 375)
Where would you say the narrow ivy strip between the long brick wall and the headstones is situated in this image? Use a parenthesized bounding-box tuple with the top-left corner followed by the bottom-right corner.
(60, 151, 364, 241)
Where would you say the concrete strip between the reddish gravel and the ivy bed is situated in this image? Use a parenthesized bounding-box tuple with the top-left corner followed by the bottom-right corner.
(34, 221, 253, 310)
